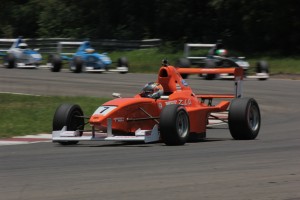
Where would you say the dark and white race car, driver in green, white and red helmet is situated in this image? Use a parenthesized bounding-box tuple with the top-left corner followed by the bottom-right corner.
(177, 41, 269, 80)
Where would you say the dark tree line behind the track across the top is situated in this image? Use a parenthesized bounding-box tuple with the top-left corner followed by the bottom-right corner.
(0, 0, 300, 55)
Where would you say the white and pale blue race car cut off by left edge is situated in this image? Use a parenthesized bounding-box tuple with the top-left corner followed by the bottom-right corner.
(0, 37, 42, 68)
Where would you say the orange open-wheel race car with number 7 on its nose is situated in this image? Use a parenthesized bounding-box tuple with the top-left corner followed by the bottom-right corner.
(52, 60, 261, 145)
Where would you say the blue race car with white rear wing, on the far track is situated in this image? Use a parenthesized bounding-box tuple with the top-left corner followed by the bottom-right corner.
(49, 41, 128, 73)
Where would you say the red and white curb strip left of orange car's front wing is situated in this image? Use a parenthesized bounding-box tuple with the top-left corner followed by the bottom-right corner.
(0, 134, 52, 146)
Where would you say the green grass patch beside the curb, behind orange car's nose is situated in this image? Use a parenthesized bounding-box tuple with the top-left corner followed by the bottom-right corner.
(0, 94, 109, 138)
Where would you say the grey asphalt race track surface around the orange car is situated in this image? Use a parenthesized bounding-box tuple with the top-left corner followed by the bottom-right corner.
(0, 68, 300, 200)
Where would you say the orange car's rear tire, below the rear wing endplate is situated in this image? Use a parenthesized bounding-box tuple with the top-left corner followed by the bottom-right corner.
(228, 98, 261, 140)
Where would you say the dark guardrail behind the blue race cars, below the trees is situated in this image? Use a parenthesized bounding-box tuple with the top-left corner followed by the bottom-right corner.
(0, 38, 162, 54)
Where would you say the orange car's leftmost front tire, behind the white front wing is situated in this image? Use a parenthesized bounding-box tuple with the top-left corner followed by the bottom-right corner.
(52, 104, 84, 145)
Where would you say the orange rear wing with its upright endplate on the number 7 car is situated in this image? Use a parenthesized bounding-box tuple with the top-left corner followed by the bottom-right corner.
(177, 67, 244, 98)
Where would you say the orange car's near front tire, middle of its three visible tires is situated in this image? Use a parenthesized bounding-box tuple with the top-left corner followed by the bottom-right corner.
(159, 104, 190, 146)
